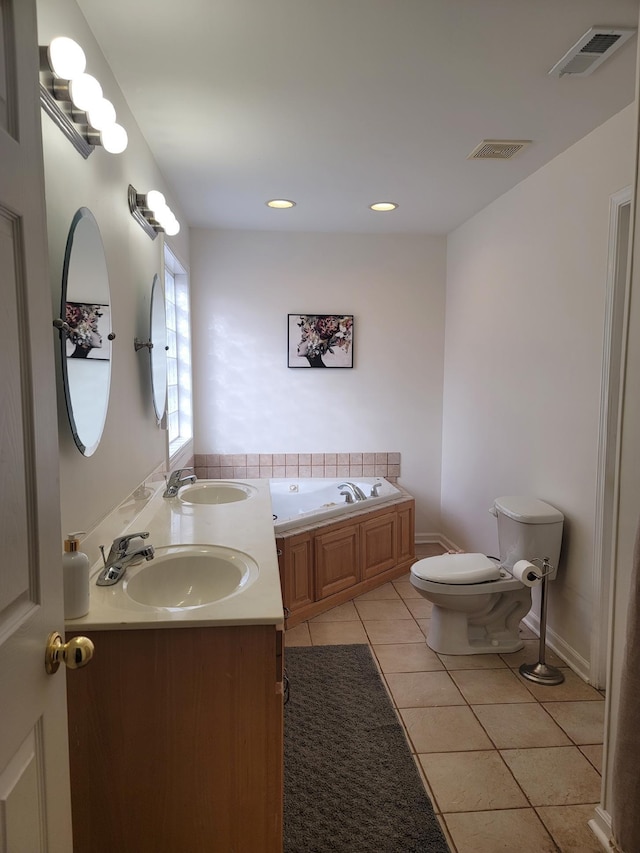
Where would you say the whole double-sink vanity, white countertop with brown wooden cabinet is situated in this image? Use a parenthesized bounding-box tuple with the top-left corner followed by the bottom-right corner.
(67, 481, 283, 853)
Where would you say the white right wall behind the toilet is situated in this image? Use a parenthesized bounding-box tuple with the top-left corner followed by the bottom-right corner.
(442, 106, 635, 661)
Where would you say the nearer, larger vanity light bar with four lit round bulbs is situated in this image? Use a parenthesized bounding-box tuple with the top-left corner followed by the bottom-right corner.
(40, 36, 129, 160)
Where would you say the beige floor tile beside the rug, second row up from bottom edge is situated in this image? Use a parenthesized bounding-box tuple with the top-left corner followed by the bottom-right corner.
(419, 750, 528, 814)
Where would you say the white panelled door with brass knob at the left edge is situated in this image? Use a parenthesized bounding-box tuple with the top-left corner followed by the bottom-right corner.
(0, 0, 71, 853)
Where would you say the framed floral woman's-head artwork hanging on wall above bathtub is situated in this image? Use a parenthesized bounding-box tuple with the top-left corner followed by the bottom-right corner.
(287, 314, 353, 367)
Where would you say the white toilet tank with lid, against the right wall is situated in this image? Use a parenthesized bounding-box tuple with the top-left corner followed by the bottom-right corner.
(492, 495, 564, 580)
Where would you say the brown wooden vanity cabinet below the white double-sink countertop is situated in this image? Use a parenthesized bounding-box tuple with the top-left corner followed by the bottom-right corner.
(67, 625, 283, 853)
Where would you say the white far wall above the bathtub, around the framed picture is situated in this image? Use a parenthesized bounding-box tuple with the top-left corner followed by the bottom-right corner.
(191, 228, 445, 533)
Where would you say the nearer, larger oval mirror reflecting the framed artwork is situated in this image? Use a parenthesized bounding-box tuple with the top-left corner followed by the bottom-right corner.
(60, 207, 112, 456)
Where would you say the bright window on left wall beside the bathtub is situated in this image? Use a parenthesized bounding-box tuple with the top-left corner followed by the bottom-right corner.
(164, 246, 193, 459)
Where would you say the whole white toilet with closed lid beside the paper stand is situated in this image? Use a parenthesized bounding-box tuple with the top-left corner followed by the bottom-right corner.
(411, 496, 564, 655)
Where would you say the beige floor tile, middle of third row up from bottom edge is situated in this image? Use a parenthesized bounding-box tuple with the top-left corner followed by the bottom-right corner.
(472, 702, 571, 749)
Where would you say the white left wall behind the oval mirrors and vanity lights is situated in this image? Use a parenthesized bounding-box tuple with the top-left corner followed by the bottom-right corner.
(38, 0, 188, 540)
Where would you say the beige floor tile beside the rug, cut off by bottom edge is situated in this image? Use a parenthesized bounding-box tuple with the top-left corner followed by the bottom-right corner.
(444, 809, 558, 853)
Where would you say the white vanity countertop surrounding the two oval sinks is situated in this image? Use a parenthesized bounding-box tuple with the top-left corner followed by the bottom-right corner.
(66, 480, 284, 631)
